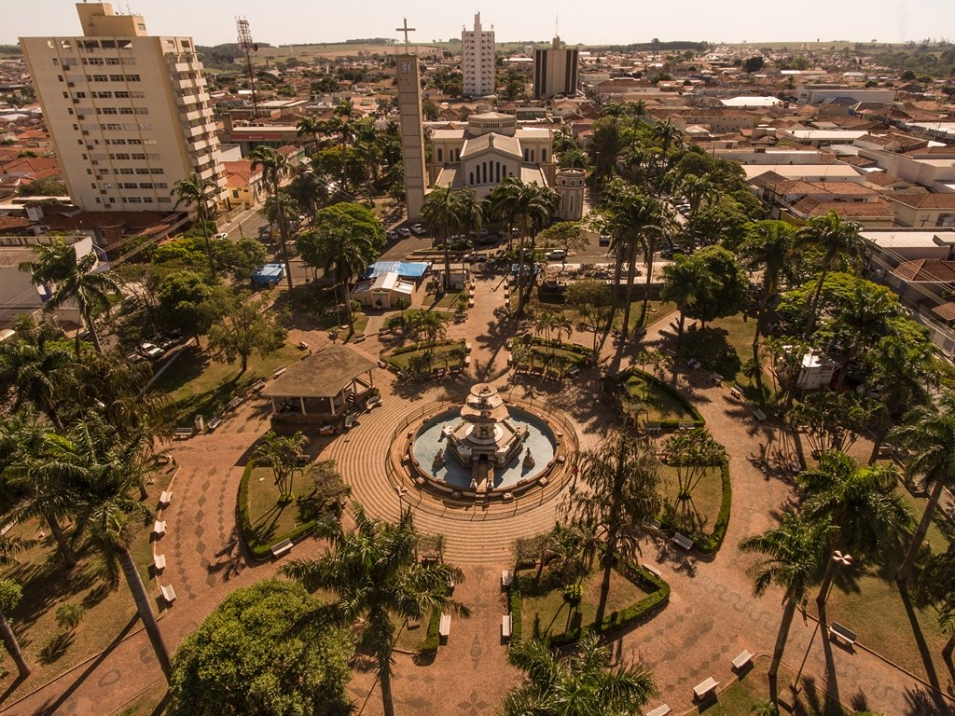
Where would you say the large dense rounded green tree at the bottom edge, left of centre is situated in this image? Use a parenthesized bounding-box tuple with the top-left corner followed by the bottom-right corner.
(169, 579, 351, 716)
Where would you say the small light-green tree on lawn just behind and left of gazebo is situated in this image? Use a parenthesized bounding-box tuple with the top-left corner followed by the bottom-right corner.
(209, 293, 288, 374)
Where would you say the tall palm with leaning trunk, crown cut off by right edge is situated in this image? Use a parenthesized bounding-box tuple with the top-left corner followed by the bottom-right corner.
(888, 391, 955, 583)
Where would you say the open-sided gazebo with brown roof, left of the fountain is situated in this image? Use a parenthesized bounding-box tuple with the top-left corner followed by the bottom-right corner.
(261, 345, 377, 430)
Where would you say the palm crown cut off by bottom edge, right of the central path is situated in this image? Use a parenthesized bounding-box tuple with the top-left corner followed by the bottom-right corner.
(500, 634, 656, 716)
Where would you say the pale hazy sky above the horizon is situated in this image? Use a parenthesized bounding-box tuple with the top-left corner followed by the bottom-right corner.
(7, 0, 955, 45)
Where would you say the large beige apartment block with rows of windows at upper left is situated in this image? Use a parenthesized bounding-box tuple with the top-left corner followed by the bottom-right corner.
(20, 3, 226, 211)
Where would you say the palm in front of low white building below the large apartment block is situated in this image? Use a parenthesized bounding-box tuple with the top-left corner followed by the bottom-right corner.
(19, 239, 119, 355)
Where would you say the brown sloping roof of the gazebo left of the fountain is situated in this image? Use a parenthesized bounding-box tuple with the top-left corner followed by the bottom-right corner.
(262, 345, 377, 398)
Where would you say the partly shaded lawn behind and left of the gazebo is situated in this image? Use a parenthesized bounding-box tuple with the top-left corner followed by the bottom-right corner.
(152, 342, 304, 426)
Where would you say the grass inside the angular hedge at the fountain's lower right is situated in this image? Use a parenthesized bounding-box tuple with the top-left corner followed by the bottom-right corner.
(518, 568, 648, 639)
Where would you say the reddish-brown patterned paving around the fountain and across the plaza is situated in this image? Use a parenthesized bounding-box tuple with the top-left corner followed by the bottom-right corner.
(0, 277, 951, 716)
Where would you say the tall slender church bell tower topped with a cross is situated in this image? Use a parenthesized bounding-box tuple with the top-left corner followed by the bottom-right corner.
(395, 20, 425, 219)
